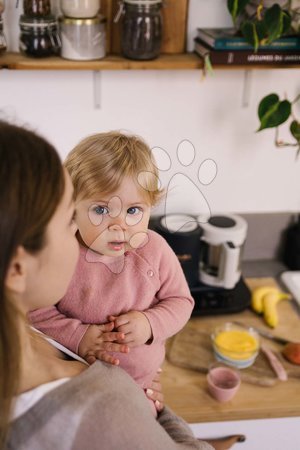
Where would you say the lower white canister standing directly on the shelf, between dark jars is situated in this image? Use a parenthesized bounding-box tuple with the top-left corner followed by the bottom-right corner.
(59, 16, 106, 61)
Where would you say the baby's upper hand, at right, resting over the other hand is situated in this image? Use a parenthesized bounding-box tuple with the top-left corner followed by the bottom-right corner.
(108, 311, 152, 347)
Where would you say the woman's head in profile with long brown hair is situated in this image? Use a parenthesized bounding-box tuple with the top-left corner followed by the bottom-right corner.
(0, 122, 78, 447)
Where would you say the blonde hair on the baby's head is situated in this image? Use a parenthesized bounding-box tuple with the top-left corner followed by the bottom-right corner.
(64, 131, 163, 206)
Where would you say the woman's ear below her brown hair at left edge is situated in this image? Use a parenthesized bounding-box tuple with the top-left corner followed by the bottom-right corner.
(5, 246, 27, 294)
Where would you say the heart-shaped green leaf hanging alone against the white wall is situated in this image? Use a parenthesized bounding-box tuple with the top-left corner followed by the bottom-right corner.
(258, 94, 292, 131)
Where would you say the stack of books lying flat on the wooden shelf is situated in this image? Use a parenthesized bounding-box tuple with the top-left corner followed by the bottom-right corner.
(194, 28, 300, 65)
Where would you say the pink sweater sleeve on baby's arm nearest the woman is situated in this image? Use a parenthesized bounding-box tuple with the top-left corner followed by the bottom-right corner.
(28, 303, 89, 353)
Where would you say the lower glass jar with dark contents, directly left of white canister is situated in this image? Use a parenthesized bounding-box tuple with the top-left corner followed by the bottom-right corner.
(19, 15, 61, 58)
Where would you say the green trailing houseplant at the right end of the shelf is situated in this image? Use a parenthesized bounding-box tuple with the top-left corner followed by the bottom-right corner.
(227, 0, 300, 156)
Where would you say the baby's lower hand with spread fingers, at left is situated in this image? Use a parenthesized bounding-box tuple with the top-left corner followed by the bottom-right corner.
(78, 322, 129, 366)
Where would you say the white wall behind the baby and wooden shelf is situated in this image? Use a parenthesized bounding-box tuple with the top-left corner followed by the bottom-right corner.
(0, 0, 300, 213)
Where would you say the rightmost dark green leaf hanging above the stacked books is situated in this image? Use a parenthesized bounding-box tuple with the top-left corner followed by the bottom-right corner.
(263, 3, 291, 43)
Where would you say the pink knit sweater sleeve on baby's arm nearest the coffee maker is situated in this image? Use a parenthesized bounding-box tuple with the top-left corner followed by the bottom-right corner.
(144, 236, 195, 342)
